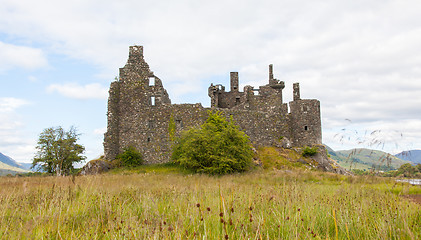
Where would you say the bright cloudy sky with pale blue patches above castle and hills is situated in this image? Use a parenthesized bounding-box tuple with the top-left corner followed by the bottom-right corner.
(0, 0, 421, 162)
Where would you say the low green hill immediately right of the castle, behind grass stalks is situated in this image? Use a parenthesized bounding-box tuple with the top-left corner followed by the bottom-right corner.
(326, 146, 410, 171)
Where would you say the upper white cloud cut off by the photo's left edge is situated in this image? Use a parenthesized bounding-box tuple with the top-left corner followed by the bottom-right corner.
(0, 41, 48, 71)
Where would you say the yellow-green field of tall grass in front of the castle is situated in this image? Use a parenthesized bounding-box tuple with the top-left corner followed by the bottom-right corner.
(0, 166, 421, 239)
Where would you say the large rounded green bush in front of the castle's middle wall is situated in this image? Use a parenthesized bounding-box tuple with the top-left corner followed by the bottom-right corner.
(172, 112, 253, 174)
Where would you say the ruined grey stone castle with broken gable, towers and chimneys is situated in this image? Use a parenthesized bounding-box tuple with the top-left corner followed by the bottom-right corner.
(104, 46, 322, 164)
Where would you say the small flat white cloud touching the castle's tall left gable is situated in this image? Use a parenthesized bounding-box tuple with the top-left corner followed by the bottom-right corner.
(47, 83, 108, 99)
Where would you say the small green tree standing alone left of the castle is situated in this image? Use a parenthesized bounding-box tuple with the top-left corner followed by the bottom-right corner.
(32, 127, 85, 176)
